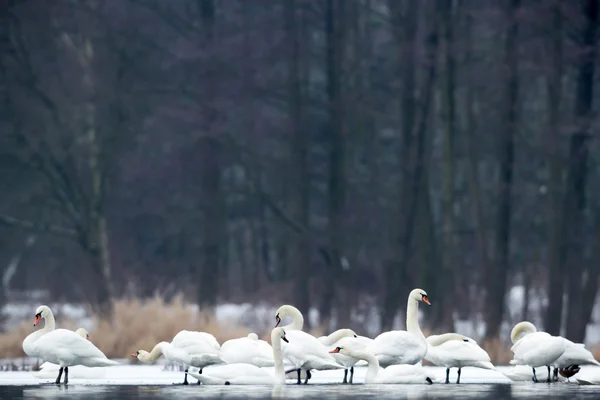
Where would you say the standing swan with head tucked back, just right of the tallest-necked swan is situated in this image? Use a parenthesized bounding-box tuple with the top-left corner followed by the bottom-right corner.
(425, 333, 496, 383)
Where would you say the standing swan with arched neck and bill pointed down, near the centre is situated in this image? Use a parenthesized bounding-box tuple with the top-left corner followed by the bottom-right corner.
(275, 305, 346, 384)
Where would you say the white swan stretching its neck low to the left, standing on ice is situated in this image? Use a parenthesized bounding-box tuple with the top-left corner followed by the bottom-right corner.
(131, 330, 225, 385)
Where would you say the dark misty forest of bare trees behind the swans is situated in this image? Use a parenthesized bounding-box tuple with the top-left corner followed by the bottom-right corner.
(0, 0, 600, 341)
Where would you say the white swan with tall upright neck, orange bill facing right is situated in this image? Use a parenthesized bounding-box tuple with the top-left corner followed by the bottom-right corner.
(367, 289, 431, 368)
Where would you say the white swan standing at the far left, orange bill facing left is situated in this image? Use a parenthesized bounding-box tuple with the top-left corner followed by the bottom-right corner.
(26, 308, 119, 385)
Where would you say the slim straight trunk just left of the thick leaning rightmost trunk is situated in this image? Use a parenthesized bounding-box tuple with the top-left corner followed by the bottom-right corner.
(544, 0, 566, 335)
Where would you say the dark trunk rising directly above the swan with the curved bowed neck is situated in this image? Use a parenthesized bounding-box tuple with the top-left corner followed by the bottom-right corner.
(285, 0, 312, 328)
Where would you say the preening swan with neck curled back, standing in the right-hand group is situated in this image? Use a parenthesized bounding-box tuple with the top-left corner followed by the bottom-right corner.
(509, 321, 566, 382)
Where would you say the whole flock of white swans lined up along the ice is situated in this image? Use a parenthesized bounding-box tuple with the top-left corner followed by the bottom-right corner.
(23, 289, 600, 385)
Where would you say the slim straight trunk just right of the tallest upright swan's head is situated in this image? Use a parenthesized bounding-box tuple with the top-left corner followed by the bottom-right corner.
(434, 0, 456, 332)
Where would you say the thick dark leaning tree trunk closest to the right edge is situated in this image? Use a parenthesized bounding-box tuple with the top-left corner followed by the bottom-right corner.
(564, 0, 599, 342)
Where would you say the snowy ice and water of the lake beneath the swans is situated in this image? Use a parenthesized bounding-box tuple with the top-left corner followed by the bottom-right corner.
(0, 365, 600, 400)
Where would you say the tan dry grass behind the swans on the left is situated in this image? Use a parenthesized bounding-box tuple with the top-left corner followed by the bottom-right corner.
(0, 296, 248, 358)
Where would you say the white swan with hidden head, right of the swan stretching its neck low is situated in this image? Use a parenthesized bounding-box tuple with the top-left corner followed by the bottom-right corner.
(221, 333, 275, 367)
